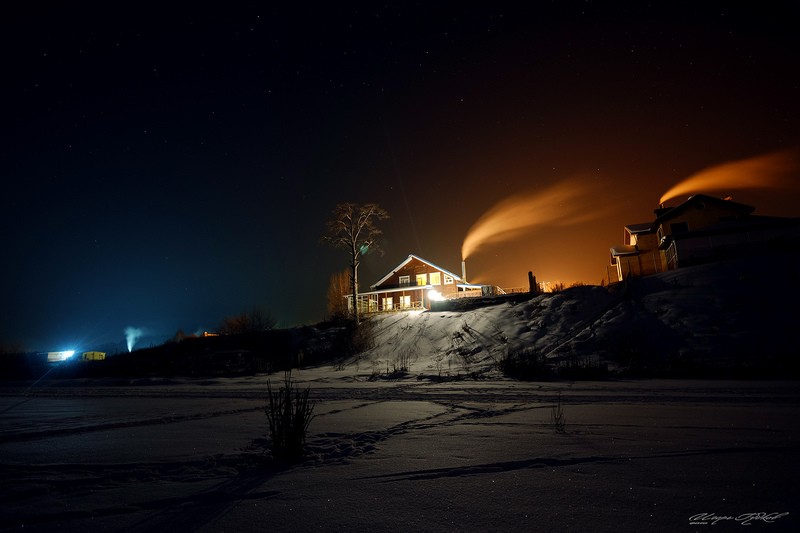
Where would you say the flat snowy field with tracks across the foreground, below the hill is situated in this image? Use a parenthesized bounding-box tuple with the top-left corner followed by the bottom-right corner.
(0, 367, 800, 532)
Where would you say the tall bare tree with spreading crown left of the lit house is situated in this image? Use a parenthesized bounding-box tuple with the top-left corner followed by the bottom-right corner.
(322, 203, 389, 324)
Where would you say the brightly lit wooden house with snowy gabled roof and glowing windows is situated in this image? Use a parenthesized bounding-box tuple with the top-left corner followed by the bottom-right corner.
(347, 254, 490, 313)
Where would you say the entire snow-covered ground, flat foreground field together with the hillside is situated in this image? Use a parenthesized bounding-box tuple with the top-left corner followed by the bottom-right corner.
(0, 261, 800, 532)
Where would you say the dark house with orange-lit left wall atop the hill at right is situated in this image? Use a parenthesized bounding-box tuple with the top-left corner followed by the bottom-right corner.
(609, 194, 800, 281)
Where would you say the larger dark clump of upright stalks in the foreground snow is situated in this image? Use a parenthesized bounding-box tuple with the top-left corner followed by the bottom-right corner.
(264, 371, 314, 462)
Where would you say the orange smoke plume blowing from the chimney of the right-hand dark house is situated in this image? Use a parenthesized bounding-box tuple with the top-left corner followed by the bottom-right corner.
(659, 150, 800, 208)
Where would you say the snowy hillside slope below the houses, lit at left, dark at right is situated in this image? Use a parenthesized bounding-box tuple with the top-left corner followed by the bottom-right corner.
(346, 254, 800, 377)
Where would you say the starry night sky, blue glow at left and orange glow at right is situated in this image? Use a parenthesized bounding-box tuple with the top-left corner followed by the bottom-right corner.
(0, 2, 800, 351)
